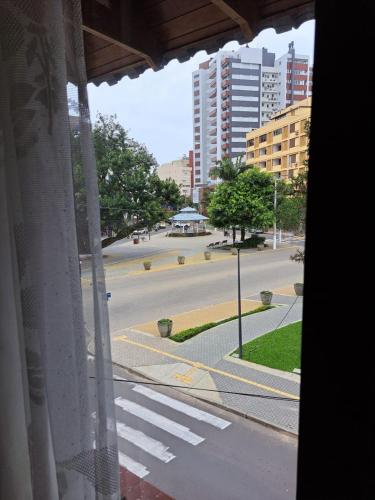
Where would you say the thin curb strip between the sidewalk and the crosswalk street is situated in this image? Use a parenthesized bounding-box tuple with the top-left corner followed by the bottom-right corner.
(107, 353, 298, 439)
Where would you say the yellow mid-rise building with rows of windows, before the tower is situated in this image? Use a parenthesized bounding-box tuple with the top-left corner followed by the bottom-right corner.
(246, 97, 311, 179)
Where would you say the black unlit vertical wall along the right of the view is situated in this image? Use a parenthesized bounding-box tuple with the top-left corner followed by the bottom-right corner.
(297, 0, 375, 500)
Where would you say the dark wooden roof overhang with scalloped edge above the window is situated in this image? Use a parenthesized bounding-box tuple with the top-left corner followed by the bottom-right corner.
(82, 0, 314, 85)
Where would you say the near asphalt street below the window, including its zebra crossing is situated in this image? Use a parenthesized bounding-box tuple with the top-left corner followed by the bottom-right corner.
(98, 369, 297, 500)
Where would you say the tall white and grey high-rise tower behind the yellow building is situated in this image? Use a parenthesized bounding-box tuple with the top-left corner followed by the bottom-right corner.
(192, 42, 311, 187)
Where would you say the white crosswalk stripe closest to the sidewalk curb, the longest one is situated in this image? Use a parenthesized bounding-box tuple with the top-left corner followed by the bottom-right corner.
(133, 385, 231, 429)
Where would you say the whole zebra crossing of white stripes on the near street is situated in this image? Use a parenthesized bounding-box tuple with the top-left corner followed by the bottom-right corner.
(111, 377, 231, 478)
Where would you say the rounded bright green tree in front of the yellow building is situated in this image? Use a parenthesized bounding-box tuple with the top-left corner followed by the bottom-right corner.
(208, 168, 274, 243)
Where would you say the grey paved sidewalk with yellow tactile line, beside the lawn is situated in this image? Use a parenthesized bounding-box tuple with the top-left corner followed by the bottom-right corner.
(105, 295, 302, 435)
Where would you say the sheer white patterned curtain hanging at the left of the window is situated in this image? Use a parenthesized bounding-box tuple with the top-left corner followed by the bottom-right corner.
(0, 0, 120, 500)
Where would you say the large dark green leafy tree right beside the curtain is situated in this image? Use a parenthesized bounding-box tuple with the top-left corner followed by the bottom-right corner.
(93, 114, 180, 246)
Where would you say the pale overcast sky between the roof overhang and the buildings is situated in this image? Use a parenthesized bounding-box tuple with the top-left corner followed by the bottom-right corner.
(88, 21, 315, 165)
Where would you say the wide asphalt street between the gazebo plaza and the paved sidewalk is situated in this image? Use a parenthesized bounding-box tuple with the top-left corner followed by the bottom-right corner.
(106, 248, 303, 333)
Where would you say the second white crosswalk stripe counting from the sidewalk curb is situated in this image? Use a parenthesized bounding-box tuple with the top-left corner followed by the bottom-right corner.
(115, 397, 204, 446)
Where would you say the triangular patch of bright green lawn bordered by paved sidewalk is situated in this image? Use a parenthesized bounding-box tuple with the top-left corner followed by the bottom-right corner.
(235, 321, 302, 372)
